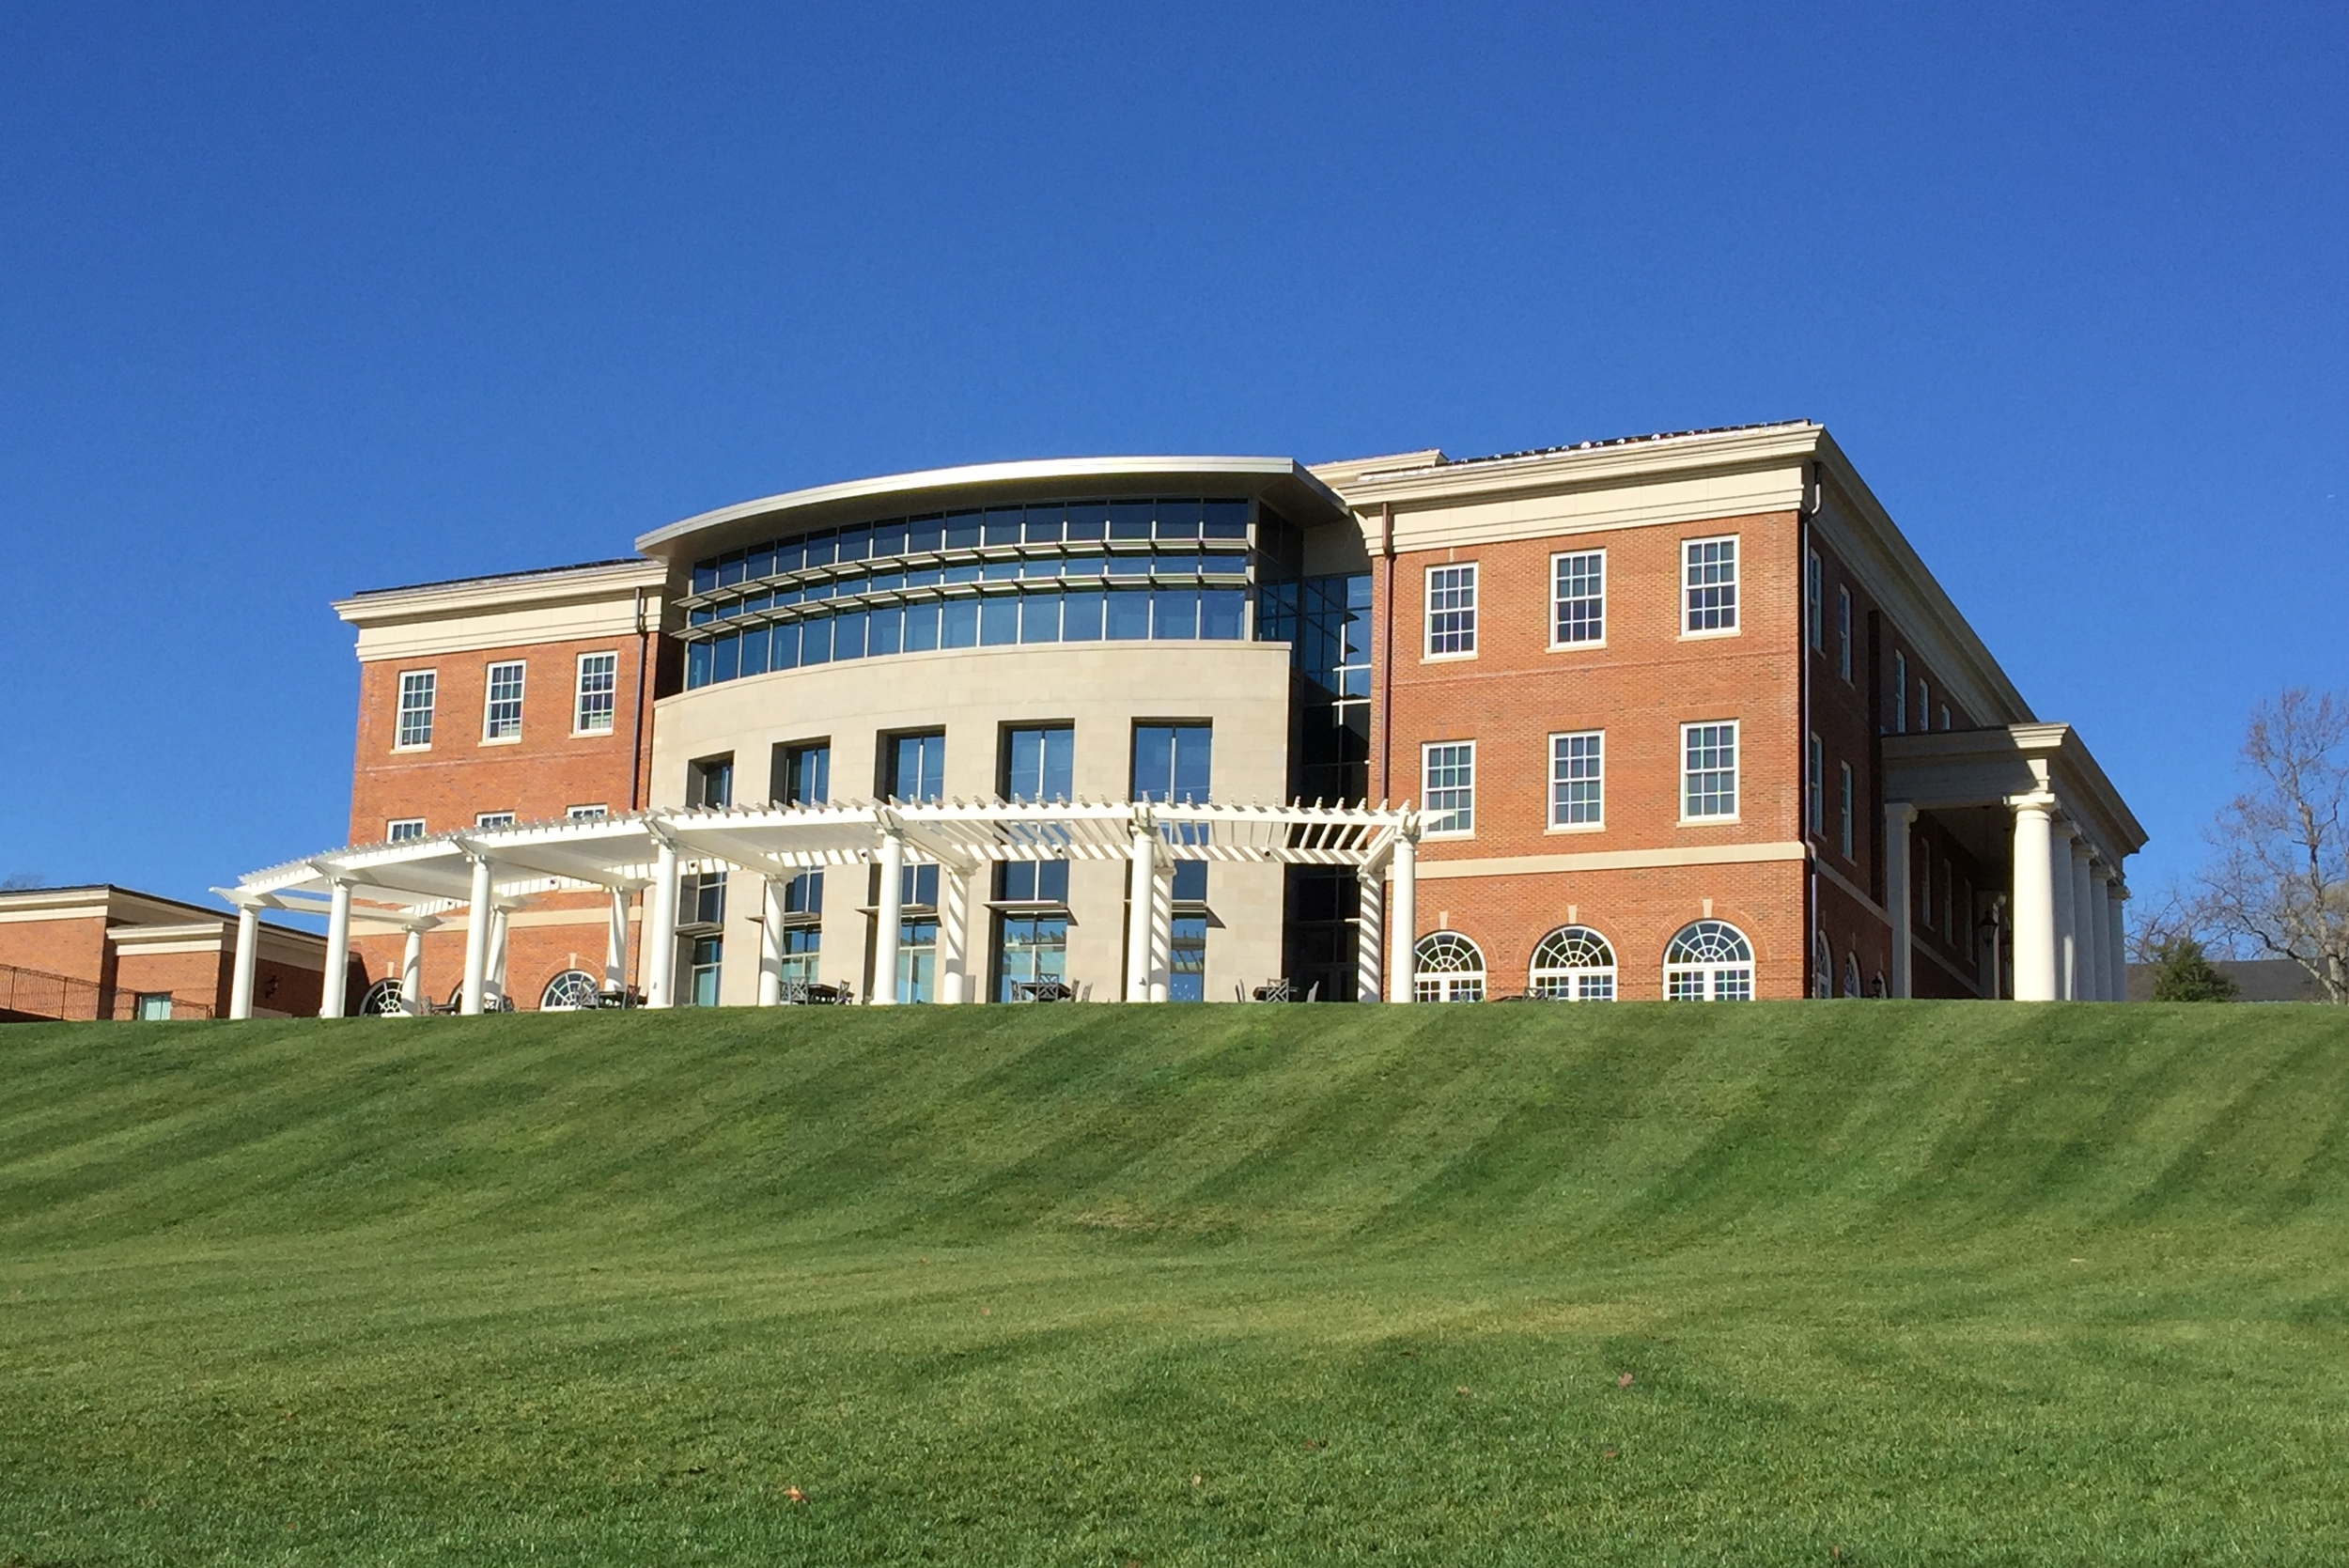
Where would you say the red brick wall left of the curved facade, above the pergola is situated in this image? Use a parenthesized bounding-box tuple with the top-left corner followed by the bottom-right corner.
(350, 636, 675, 843)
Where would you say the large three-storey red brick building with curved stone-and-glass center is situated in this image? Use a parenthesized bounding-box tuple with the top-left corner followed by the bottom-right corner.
(224, 423, 2145, 1009)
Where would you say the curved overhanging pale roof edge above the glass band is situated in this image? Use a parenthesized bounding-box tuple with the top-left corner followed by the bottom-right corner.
(637, 458, 1348, 559)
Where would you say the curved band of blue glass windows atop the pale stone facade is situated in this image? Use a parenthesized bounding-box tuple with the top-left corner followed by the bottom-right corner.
(684, 498, 1252, 688)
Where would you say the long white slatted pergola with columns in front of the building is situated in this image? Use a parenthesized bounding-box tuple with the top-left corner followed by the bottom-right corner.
(216, 800, 1419, 1018)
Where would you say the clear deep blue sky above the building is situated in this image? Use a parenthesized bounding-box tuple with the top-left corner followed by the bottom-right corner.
(0, 0, 2349, 896)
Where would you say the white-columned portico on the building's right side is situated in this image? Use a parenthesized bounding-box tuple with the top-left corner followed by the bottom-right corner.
(1884, 723, 2145, 1002)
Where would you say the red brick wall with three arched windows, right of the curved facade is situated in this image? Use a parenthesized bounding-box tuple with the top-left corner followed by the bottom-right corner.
(1372, 514, 1809, 998)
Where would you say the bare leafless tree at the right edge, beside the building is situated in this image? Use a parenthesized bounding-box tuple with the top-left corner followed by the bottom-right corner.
(2194, 688, 2349, 1004)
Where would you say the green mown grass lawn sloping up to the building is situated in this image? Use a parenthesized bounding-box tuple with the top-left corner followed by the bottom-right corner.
(0, 1002, 2349, 1568)
